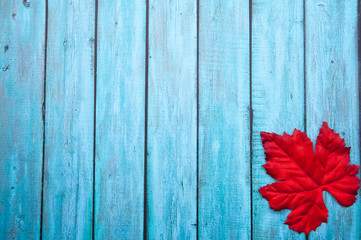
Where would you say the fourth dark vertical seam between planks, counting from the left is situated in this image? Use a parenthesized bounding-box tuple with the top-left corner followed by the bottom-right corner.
(196, 0, 199, 240)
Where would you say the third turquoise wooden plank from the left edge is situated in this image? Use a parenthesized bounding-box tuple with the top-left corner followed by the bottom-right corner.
(95, 0, 146, 239)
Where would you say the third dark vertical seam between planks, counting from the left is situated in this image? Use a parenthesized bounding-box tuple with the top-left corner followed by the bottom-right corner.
(143, 0, 149, 239)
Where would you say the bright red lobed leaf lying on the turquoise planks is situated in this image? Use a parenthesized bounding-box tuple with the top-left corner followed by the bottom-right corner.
(259, 123, 360, 236)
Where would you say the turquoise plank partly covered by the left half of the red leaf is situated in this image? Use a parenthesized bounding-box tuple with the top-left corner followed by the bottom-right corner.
(252, 0, 305, 239)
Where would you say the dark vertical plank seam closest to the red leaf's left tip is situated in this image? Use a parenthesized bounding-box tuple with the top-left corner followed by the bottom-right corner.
(248, 0, 253, 240)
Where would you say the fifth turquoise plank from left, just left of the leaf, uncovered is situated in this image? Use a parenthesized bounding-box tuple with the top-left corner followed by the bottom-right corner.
(199, 0, 251, 239)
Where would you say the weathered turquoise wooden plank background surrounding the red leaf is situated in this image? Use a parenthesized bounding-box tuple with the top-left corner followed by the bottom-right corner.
(0, 0, 361, 239)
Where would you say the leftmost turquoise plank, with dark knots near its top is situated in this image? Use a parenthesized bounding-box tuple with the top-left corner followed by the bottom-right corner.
(0, 1, 45, 239)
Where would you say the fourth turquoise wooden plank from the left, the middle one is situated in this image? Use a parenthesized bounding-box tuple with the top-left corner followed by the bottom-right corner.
(147, 0, 197, 239)
